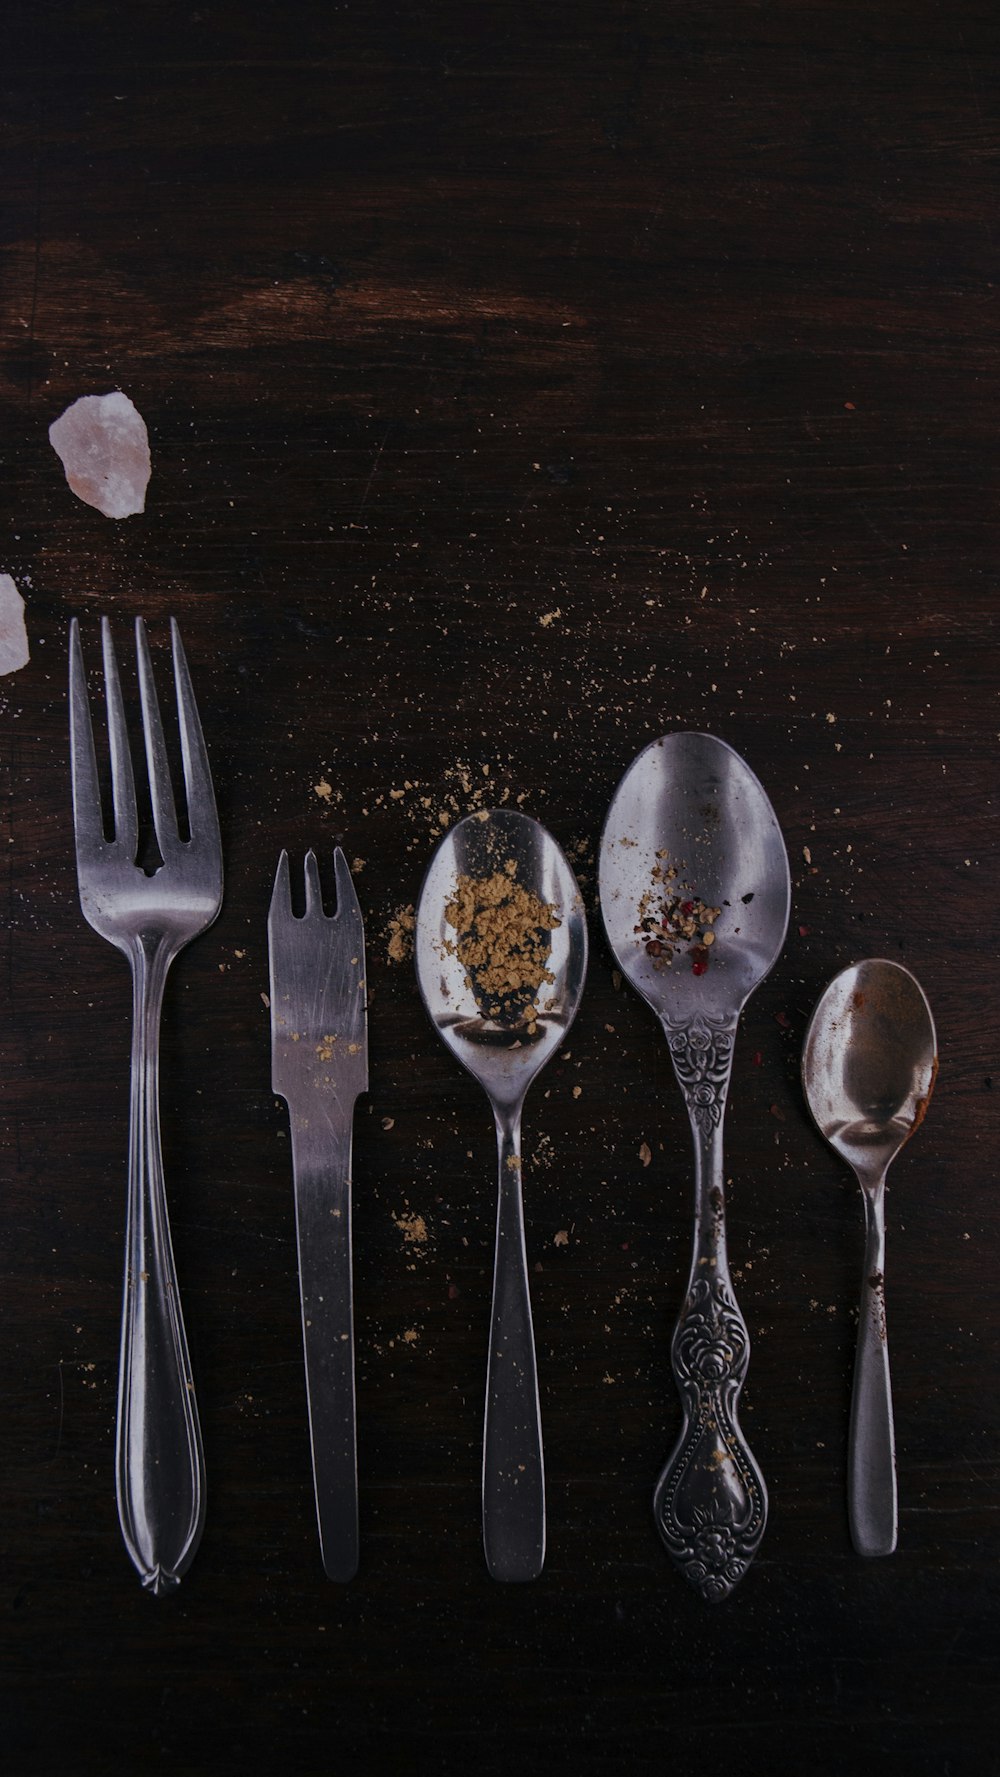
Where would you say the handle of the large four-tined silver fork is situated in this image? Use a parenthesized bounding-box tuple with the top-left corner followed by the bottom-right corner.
(115, 933, 204, 1596)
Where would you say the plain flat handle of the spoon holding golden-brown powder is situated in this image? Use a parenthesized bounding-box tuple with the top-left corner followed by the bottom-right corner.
(483, 1109, 545, 1580)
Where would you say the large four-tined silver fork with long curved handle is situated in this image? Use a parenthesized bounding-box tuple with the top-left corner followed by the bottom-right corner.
(69, 617, 222, 1596)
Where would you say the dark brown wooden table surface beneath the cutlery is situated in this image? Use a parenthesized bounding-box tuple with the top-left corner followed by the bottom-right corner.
(0, 0, 1000, 1777)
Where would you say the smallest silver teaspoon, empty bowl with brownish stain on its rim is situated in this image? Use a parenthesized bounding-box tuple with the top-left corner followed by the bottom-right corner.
(803, 958, 938, 1555)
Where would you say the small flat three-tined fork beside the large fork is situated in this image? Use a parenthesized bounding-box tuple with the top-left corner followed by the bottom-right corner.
(268, 846, 368, 1580)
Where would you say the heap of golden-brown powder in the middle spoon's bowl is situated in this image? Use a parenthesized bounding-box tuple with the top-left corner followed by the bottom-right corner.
(444, 858, 561, 1020)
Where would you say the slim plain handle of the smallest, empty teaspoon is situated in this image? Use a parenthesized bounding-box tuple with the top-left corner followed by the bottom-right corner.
(847, 1173, 897, 1555)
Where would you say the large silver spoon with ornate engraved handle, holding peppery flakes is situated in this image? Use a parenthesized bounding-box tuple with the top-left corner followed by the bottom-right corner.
(600, 734, 790, 1601)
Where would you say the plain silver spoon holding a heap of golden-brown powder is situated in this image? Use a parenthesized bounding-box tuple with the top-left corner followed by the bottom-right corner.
(416, 809, 586, 1580)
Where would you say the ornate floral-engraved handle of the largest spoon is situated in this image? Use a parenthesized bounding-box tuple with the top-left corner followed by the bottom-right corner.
(654, 1018, 767, 1603)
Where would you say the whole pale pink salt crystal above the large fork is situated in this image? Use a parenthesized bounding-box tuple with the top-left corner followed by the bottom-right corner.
(48, 389, 149, 519)
